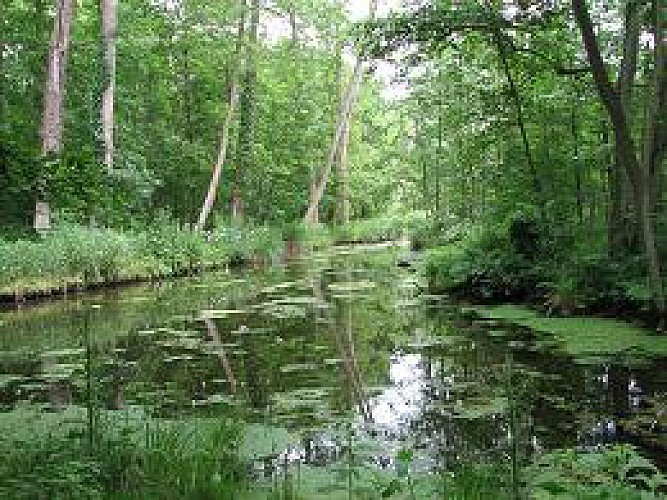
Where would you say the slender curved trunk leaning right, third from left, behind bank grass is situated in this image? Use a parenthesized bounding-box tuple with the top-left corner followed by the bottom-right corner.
(195, 0, 246, 231)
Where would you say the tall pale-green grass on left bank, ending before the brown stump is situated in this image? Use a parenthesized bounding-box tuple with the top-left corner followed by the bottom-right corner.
(0, 224, 283, 298)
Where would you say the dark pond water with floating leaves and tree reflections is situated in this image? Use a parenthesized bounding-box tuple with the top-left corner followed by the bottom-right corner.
(0, 244, 667, 490)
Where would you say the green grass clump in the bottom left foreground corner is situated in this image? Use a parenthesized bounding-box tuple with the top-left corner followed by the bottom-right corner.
(0, 408, 245, 499)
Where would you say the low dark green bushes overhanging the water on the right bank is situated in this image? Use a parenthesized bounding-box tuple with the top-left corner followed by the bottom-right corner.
(423, 216, 650, 314)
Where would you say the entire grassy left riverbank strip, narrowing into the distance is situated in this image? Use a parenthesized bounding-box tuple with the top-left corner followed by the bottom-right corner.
(0, 217, 412, 306)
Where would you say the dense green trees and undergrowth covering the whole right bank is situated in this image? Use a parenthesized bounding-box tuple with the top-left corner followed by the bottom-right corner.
(362, 1, 667, 323)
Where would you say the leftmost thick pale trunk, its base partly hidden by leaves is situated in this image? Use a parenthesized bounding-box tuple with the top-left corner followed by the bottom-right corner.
(34, 0, 74, 231)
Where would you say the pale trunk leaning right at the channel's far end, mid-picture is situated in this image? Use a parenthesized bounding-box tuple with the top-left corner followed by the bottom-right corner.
(304, 0, 378, 224)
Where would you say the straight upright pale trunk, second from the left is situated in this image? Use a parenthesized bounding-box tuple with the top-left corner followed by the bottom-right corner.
(102, 0, 118, 171)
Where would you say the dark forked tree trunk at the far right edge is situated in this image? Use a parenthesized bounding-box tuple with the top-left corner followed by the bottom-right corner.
(572, 0, 667, 329)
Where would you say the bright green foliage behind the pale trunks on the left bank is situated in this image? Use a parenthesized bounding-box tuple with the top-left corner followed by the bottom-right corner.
(0, 0, 407, 226)
